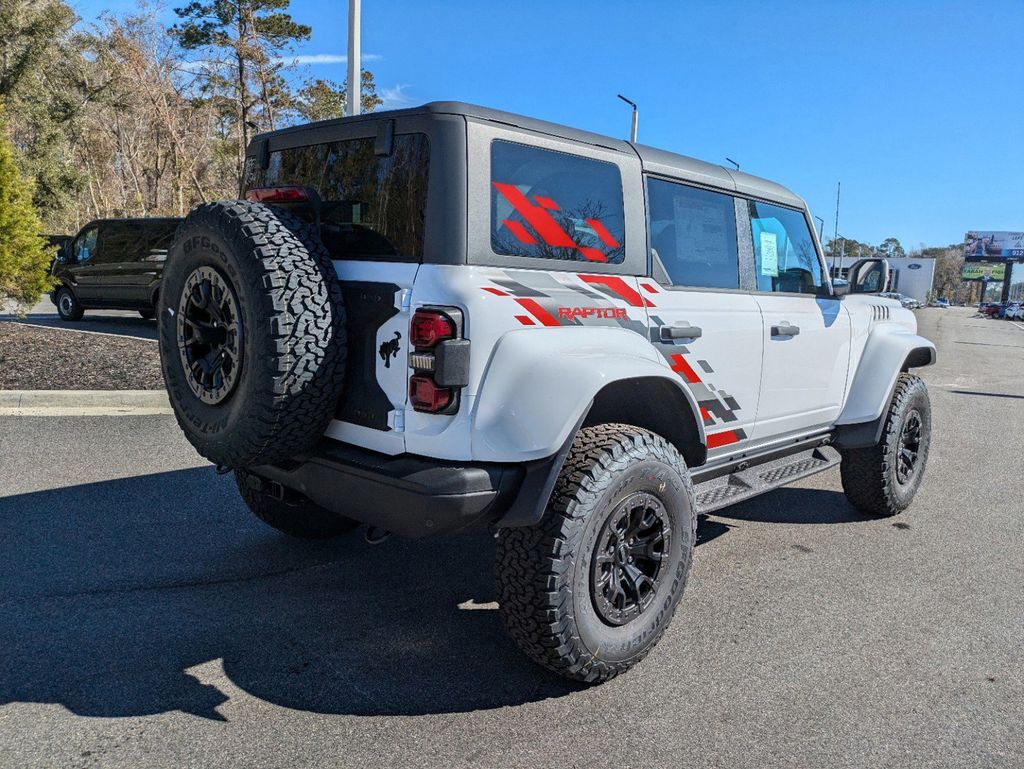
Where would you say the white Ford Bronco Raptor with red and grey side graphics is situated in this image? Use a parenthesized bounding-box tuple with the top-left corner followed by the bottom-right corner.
(160, 102, 935, 681)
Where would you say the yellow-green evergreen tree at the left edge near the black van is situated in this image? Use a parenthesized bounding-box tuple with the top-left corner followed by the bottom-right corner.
(0, 105, 51, 307)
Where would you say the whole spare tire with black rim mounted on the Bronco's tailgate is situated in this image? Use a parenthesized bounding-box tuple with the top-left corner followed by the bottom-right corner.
(159, 201, 346, 468)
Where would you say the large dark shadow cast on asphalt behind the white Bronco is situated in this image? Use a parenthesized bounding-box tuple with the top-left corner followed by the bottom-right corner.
(0, 467, 579, 719)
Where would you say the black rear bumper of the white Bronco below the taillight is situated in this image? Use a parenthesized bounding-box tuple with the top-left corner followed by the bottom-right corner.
(250, 440, 536, 538)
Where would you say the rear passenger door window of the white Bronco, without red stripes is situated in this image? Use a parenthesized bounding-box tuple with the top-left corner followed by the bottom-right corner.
(647, 179, 739, 289)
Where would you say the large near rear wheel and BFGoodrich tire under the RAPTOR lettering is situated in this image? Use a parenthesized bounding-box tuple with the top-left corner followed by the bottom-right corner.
(496, 424, 696, 682)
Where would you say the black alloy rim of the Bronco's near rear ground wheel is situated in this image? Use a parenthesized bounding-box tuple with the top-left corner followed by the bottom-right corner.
(591, 492, 672, 626)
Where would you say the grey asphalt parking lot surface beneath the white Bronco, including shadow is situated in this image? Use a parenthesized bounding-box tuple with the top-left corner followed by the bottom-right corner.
(0, 308, 1024, 769)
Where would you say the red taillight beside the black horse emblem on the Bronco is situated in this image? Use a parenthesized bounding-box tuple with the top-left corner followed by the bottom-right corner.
(409, 307, 469, 414)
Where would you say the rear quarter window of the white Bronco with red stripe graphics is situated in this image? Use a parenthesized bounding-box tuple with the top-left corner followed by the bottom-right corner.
(490, 141, 626, 264)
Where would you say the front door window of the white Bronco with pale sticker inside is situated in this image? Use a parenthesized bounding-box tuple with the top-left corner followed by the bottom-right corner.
(749, 201, 821, 294)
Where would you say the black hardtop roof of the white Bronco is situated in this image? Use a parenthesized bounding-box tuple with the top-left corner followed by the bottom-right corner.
(254, 101, 805, 208)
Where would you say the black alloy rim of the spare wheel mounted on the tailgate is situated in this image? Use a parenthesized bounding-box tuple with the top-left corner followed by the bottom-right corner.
(177, 266, 243, 404)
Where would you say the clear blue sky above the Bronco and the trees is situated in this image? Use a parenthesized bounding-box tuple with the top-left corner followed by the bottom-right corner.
(73, 0, 1024, 248)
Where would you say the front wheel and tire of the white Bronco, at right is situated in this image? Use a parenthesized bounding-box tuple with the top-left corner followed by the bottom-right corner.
(840, 374, 932, 516)
